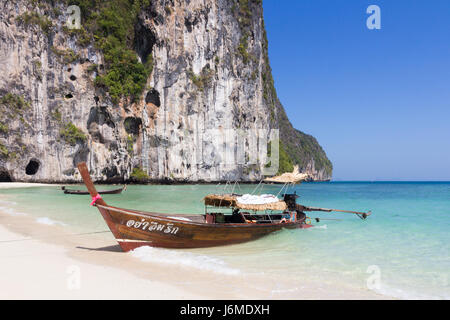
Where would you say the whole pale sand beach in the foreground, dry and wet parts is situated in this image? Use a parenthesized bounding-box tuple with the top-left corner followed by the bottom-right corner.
(0, 213, 387, 299)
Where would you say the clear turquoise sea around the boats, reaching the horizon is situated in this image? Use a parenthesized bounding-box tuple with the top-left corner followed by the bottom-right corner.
(0, 182, 450, 299)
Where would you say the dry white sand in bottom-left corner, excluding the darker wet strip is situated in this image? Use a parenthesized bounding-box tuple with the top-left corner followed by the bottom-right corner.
(0, 227, 201, 299)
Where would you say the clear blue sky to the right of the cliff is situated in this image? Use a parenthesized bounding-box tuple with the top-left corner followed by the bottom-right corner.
(264, 0, 450, 181)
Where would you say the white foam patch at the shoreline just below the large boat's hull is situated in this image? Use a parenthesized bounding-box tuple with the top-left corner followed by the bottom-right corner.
(131, 247, 241, 275)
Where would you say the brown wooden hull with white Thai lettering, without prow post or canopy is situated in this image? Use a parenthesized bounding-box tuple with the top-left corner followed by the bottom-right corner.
(97, 205, 309, 251)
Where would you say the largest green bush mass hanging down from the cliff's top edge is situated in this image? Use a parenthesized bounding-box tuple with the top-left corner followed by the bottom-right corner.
(68, 0, 153, 103)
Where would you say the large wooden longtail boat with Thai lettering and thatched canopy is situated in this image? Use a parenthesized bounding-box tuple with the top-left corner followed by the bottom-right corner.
(78, 162, 367, 251)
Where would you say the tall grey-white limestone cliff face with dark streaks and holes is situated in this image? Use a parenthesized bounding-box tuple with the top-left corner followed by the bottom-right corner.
(0, 0, 332, 182)
